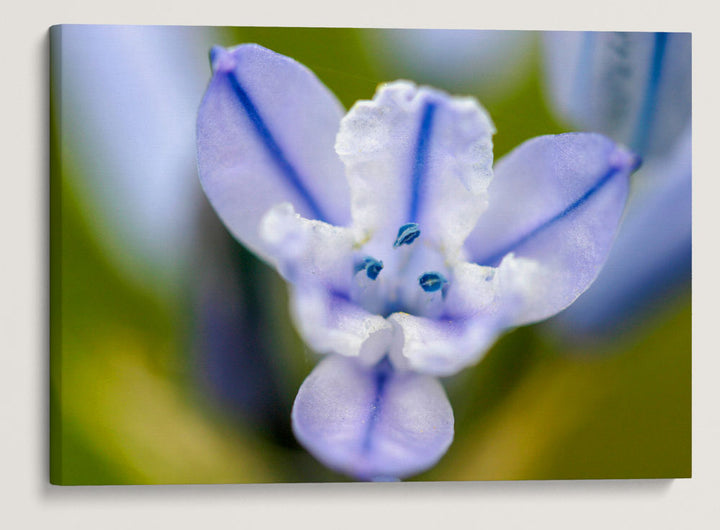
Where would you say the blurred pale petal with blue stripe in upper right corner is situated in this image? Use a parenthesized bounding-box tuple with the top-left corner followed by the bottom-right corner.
(545, 32, 692, 157)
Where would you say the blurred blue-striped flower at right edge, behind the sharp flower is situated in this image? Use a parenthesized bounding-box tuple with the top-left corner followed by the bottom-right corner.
(545, 32, 692, 340)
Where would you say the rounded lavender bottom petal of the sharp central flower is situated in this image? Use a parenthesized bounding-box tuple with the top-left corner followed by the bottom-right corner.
(292, 356, 454, 480)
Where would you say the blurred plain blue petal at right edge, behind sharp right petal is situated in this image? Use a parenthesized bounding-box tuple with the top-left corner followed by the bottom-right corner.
(555, 129, 692, 339)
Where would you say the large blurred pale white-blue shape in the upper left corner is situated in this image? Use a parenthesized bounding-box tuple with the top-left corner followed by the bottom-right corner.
(53, 25, 221, 288)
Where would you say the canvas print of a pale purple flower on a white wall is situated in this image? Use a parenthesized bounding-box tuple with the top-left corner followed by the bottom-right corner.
(50, 25, 692, 485)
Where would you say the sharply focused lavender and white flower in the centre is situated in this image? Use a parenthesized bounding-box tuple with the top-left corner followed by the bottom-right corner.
(197, 44, 637, 480)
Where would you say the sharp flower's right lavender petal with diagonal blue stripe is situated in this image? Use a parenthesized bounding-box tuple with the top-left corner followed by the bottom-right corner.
(466, 133, 637, 325)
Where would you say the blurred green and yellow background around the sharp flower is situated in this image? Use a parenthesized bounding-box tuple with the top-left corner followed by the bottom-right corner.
(50, 27, 691, 484)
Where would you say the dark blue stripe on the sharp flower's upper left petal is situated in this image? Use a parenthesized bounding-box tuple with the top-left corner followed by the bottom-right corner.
(228, 72, 328, 221)
